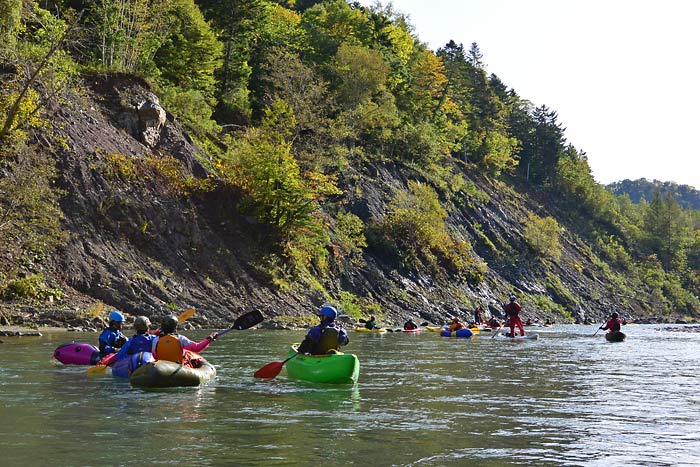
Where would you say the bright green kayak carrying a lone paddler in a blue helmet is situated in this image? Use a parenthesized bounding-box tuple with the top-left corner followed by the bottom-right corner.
(285, 344, 360, 384)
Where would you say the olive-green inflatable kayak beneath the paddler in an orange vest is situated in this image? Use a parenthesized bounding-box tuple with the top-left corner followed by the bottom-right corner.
(129, 359, 216, 388)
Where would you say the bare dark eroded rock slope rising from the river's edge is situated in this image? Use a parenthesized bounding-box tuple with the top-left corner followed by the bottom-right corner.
(2, 76, 660, 326)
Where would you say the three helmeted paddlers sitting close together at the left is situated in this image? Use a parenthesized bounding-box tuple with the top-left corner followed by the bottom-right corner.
(98, 310, 216, 370)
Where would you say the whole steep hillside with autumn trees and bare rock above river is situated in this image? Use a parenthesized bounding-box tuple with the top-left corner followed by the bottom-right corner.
(0, 0, 700, 325)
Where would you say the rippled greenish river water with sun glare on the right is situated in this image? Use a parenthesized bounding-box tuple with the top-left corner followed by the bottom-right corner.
(0, 325, 700, 466)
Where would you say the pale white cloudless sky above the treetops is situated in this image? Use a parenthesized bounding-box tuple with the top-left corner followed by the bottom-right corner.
(360, 0, 700, 189)
